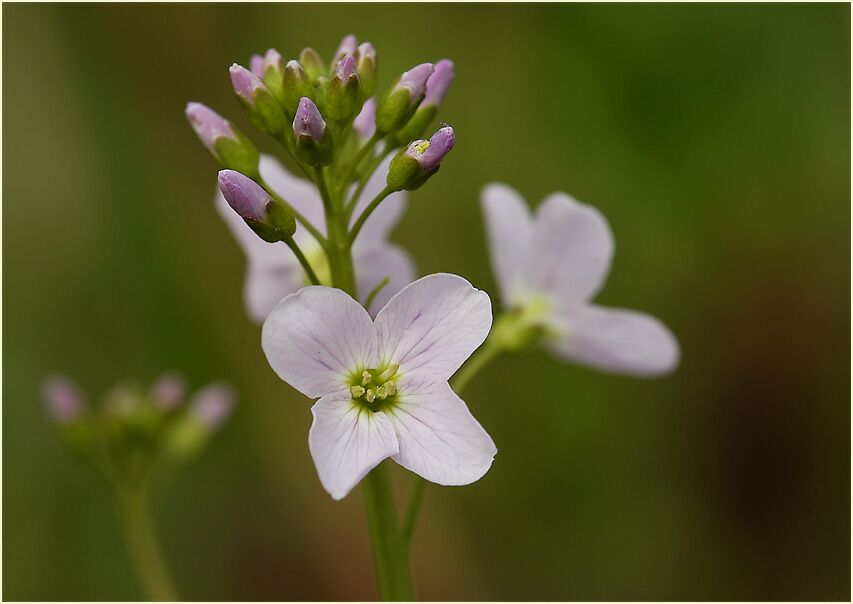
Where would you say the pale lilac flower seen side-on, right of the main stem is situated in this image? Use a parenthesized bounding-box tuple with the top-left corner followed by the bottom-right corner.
(482, 183, 679, 376)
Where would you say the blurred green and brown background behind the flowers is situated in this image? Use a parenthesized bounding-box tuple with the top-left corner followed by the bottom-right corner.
(3, 4, 850, 600)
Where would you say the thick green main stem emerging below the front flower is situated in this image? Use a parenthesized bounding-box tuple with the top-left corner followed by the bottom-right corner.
(362, 462, 415, 602)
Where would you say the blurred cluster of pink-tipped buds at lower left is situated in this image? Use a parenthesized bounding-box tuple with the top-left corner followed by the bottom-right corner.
(43, 372, 234, 489)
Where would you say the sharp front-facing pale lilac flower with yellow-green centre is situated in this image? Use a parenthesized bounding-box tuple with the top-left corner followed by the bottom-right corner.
(262, 274, 497, 499)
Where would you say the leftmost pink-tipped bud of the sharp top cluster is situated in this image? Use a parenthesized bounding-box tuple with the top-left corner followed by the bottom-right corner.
(186, 103, 258, 176)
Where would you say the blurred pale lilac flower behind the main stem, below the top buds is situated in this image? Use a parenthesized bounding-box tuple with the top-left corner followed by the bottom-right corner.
(216, 155, 415, 323)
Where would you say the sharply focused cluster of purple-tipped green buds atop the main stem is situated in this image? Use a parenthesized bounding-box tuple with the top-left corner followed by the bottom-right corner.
(186, 35, 454, 242)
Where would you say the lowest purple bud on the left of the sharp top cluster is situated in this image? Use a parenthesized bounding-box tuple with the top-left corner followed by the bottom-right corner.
(219, 170, 296, 243)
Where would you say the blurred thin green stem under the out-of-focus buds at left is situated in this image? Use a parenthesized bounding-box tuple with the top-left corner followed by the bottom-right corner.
(119, 492, 178, 601)
